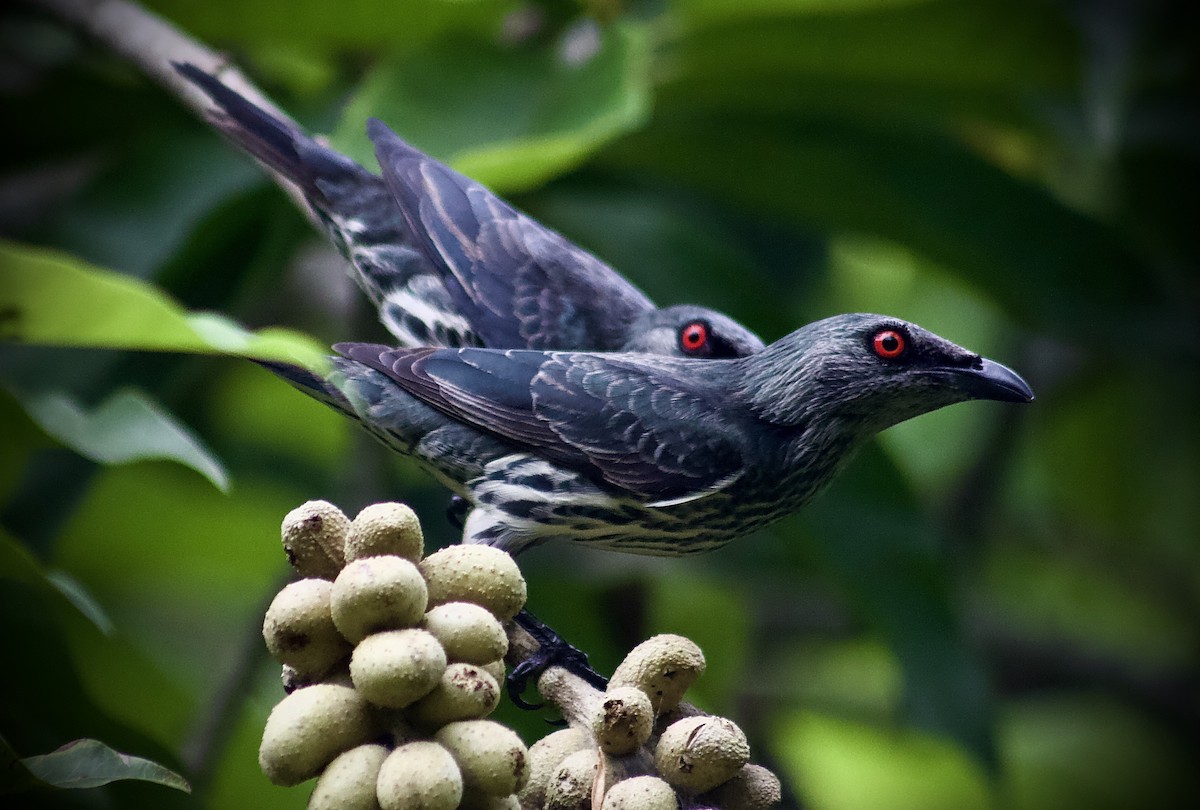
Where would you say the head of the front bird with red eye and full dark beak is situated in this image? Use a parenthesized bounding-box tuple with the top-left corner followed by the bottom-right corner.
(740, 313, 1033, 436)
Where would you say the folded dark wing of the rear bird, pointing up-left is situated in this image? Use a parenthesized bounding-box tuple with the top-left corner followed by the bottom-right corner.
(367, 120, 654, 350)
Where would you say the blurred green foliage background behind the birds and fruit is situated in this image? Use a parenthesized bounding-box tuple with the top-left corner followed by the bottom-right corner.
(0, 0, 1200, 810)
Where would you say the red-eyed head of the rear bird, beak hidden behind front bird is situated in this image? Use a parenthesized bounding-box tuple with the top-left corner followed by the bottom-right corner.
(622, 304, 763, 360)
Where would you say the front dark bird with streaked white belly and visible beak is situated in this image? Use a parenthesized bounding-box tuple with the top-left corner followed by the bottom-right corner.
(302, 314, 1033, 556)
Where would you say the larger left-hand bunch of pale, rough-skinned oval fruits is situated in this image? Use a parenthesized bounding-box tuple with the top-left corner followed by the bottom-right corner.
(259, 502, 528, 810)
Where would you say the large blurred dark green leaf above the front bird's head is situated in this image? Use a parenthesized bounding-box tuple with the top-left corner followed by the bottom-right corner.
(605, 0, 1154, 337)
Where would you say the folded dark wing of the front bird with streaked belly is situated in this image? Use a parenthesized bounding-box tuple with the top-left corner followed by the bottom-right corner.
(335, 343, 744, 505)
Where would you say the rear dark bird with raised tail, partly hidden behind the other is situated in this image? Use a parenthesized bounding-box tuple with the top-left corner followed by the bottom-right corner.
(175, 64, 762, 358)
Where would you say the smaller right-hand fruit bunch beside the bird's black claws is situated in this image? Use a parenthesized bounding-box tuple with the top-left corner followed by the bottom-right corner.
(520, 635, 780, 810)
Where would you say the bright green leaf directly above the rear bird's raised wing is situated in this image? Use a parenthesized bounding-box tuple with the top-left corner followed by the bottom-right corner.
(334, 24, 649, 192)
